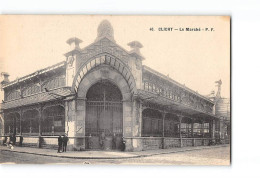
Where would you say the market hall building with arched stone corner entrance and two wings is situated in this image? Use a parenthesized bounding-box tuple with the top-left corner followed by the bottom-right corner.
(0, 20, 228, 151)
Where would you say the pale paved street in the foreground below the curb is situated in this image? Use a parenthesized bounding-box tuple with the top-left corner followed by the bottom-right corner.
(0, 146, 230, 165)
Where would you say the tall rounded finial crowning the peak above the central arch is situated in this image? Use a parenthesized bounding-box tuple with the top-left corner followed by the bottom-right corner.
(96, 20, 115, 42)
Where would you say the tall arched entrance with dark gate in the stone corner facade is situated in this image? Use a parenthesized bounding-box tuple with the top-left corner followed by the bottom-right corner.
(85, 80, 123, 150)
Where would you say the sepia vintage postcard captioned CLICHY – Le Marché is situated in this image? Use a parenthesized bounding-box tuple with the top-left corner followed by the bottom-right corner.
(0, 15, 231, 165)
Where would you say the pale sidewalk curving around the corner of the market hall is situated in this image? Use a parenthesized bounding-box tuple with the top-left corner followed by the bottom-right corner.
(0, 144, 229, 159)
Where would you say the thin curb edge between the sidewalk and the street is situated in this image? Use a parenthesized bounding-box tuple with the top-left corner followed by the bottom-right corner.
(0, 145, 227, 160)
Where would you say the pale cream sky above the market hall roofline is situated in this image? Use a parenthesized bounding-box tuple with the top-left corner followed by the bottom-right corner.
(0, 15, 230, 97)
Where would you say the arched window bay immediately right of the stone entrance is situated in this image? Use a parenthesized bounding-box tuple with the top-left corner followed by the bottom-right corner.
(142, 109, 163, 137)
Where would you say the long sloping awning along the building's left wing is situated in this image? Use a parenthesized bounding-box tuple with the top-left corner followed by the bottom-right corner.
(1, 87, 73, 110)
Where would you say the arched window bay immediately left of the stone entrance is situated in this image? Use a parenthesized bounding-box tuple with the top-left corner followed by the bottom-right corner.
(42, 105, 65, 135)
